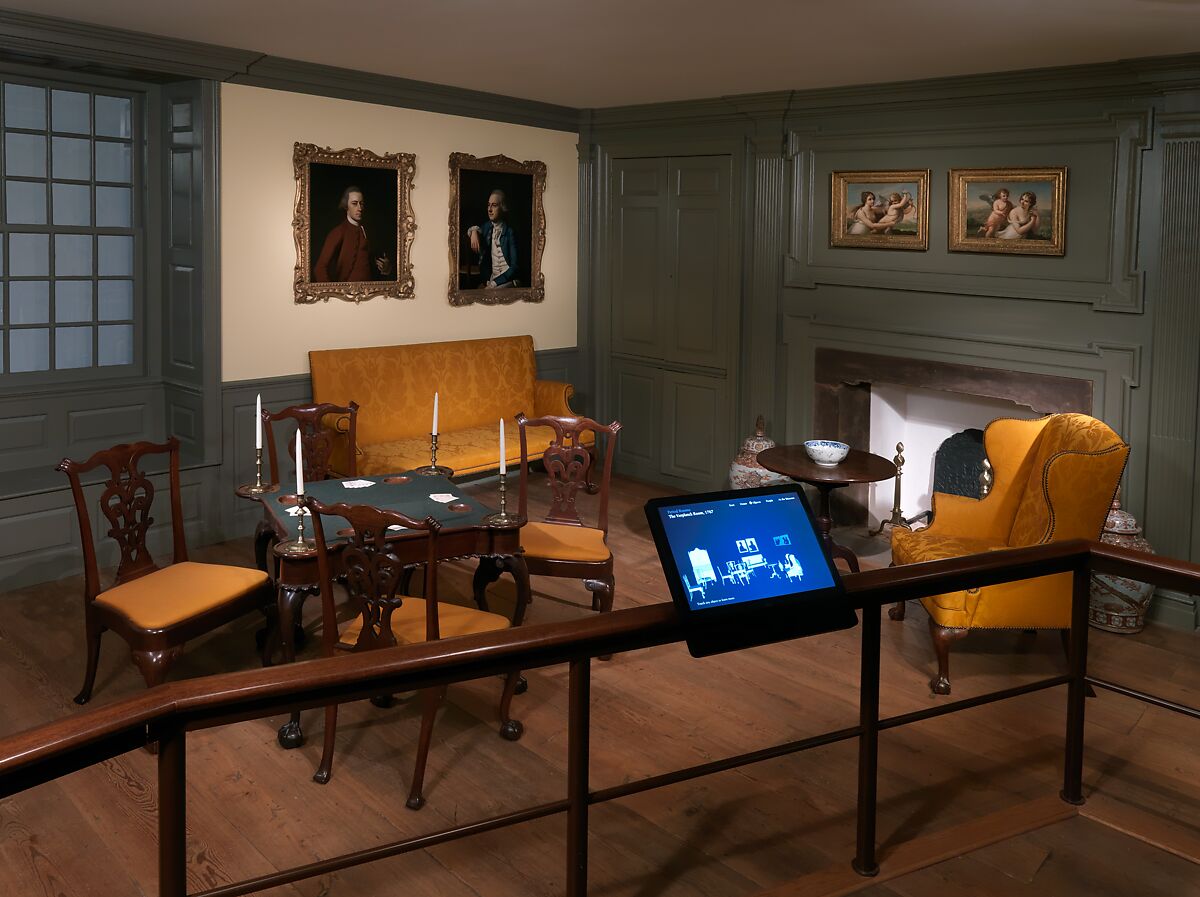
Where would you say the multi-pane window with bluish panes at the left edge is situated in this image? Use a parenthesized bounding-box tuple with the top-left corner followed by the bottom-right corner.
(0, 79, 140, 375)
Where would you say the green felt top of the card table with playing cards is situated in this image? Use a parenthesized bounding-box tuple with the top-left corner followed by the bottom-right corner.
(262, 472, 494, 541)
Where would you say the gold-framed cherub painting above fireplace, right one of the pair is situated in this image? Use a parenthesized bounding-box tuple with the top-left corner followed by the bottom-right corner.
(948, 165, 1067, 255)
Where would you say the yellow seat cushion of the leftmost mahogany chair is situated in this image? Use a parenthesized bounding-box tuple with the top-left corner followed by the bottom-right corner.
(96, 561, 266, 631)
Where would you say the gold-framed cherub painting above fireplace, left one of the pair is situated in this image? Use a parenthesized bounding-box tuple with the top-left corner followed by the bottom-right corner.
(829, 168, 929, 252)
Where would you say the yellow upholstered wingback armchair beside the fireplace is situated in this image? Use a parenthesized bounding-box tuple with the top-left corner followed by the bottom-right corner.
(892, 414, 1129, 694)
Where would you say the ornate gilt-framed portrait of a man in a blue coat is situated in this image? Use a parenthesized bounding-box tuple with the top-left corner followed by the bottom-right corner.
(448, 152, 546, 306)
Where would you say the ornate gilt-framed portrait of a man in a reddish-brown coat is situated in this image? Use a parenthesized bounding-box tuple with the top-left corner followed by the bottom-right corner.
(292, 143, 416, 305)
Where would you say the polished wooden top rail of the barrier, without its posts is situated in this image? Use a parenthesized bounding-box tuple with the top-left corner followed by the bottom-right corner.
(0, 540, 1200, 796)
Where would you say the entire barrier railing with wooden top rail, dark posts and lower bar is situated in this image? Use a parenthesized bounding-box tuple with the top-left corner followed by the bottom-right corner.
(0, 541, 1200, 897)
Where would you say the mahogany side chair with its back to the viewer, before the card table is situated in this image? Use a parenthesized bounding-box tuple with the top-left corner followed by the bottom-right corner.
(305, 495, 524, 809)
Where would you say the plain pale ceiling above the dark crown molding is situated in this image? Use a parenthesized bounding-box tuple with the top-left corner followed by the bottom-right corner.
(0, 0, 1200, 108)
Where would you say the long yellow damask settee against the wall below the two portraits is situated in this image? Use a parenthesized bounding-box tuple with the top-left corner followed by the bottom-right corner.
(308, 336, 590, 476)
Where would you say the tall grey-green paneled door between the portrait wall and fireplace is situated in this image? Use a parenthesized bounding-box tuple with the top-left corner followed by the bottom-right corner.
(608, 156, 740, 488)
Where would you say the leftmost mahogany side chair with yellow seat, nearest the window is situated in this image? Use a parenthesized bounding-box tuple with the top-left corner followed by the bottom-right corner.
(56, 437, 275, 704)
